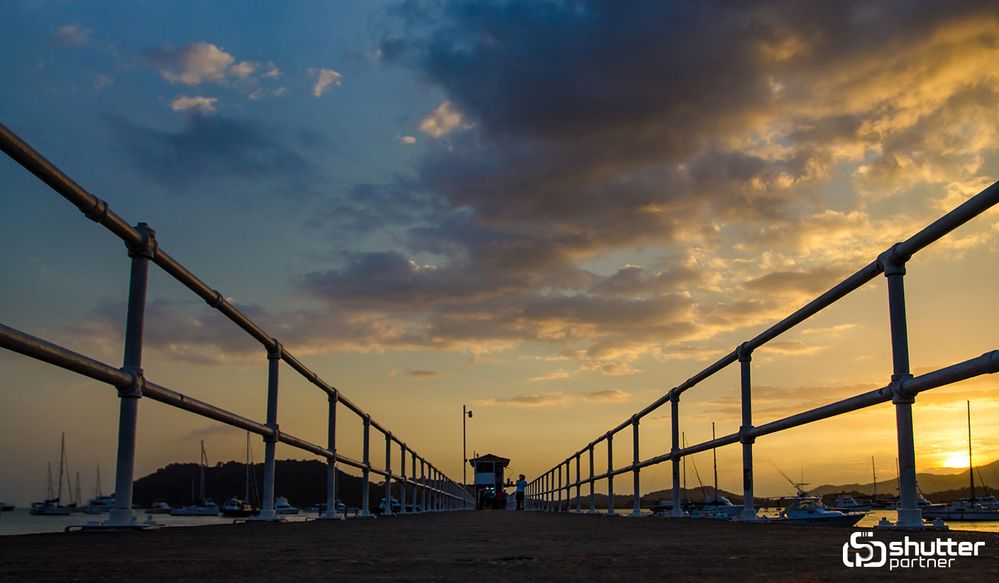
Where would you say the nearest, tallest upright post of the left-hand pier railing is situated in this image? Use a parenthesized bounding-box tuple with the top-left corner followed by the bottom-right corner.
(108, 223, 156, 525)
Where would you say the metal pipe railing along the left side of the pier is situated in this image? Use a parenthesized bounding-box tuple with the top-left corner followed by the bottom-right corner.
(0, 124, 474, 526)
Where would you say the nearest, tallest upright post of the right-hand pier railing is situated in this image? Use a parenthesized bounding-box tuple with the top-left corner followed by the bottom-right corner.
(878, 243, 923, 530)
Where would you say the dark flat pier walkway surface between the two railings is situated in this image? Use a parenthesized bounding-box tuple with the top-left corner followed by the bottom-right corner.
(0, 511, 999, 582)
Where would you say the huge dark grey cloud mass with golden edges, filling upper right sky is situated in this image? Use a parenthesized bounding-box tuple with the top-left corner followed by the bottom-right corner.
(288, 0, 999, 368)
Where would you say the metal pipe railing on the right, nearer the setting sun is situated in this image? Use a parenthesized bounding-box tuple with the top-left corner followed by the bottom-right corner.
(527, 182, 999, 529)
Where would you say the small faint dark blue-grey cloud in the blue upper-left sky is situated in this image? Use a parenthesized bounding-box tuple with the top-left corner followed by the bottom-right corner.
(106, 113, 315, 196)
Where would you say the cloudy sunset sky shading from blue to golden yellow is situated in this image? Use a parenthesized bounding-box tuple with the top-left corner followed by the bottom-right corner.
(0, 0, 999, 504)
